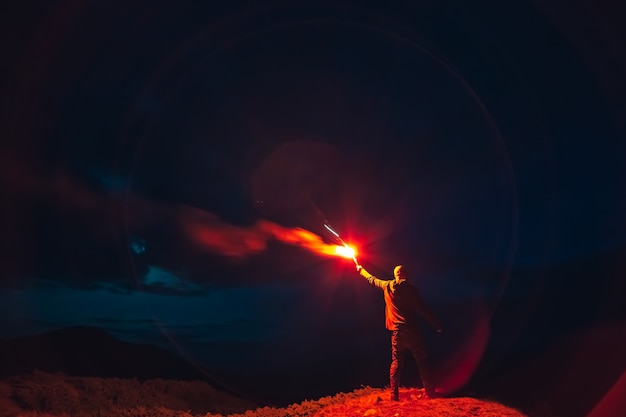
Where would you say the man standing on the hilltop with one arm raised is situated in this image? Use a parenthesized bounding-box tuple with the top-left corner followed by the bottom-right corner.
(356, 264, 442, 401)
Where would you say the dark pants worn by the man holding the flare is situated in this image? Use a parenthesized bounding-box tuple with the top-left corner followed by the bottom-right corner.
(389, 328, 434, 394)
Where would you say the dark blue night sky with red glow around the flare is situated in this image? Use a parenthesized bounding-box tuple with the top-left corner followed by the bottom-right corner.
(0, 0, 626, 410)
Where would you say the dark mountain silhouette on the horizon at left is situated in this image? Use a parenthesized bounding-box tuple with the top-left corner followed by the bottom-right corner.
(0, 326, 217, 382)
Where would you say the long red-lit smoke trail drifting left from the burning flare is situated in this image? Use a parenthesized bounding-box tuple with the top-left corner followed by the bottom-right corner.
(0, 154, 341, 264)
